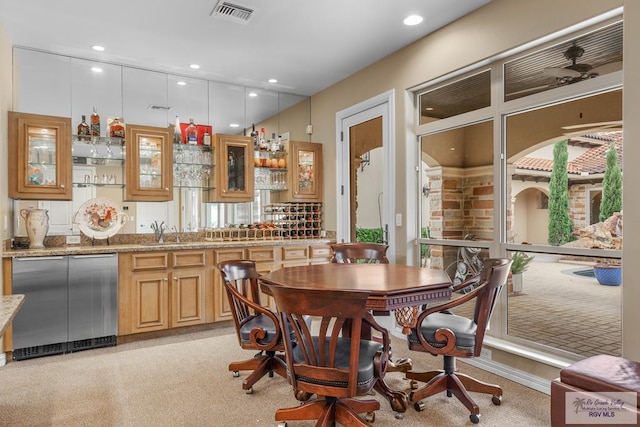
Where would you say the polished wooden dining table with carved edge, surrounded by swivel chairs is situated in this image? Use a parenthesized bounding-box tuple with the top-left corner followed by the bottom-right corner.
(260, 263, 452, 413)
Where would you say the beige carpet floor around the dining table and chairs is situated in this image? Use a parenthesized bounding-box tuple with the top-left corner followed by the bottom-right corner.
(0, 327, 549, 427)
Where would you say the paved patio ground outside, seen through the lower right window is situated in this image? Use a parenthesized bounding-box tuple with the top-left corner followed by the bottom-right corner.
(507, 255, 622, 357)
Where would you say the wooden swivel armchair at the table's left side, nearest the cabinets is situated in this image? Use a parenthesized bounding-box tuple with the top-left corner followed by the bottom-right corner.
(217, 260, 287, 394)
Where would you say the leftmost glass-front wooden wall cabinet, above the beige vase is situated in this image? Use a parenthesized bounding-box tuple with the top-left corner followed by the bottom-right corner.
(7, 112, 73, 200)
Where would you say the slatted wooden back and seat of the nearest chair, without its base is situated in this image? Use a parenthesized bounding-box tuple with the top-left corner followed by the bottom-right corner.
(271, 286, 382, 398)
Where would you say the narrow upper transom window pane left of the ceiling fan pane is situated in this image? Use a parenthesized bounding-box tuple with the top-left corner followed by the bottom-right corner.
(418, 70, 491, 125)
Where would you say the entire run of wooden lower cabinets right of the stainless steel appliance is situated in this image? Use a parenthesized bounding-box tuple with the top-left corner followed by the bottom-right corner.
(118, 245, 331, 335)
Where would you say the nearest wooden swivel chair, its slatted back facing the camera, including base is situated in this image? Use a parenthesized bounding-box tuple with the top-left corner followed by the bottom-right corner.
(270, 286, 389, 426)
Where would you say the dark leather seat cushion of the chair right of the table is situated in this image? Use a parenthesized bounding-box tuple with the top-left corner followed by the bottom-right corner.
(408, 313, 477, 351)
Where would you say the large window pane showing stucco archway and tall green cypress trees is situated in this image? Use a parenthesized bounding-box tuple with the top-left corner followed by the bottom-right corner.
(507, 90, 623, 250)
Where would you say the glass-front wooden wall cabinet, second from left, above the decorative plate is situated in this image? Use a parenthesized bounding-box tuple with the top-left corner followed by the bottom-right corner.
(125, 124, 173, 202)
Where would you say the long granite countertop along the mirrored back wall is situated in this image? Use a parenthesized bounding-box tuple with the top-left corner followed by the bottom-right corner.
(2, 239, 333, 258)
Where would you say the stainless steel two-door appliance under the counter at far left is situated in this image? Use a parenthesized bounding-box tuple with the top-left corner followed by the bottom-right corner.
(13, 254, 118, 360)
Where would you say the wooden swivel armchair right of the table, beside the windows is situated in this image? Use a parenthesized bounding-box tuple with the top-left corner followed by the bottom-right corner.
(406, 258, 512, 424)
